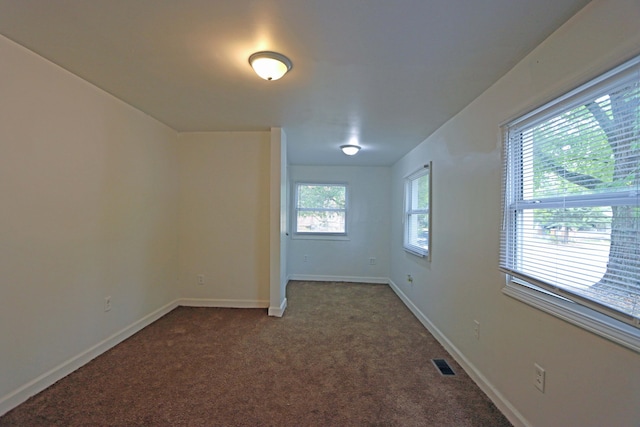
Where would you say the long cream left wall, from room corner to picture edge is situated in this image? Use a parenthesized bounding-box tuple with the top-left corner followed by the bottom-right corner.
(0, 36, 178, 408)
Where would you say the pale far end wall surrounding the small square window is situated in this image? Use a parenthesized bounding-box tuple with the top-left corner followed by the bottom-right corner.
(287, 165, 391, 283)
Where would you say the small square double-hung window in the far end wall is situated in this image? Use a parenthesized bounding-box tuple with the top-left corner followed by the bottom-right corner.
(295, 183, 347, 235)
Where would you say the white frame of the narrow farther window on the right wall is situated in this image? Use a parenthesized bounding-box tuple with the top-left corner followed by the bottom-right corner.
(402, 162, 433, 261)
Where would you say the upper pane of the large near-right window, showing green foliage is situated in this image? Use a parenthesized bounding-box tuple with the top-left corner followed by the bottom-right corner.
(522, 86, 639, 198)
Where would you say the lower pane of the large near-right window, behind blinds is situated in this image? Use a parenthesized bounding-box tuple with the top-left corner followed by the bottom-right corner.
(517, 206, 640, 316)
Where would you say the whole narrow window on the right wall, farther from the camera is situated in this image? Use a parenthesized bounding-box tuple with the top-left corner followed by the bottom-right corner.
(404, 164, 431, 257)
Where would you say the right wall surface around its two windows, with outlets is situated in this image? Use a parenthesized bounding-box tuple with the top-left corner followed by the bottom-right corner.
(390, 0, 640, 427)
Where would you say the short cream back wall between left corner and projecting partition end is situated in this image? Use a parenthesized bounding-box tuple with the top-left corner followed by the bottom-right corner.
(178, 132, 271, 307)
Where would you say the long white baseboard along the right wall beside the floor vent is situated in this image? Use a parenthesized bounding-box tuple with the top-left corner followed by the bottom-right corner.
(388, 279, 531, 427)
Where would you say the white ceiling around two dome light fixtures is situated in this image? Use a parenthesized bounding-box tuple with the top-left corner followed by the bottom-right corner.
(0, 0, 588, 165)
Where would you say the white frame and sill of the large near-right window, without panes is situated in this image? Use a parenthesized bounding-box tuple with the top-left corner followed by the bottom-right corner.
(500, 57, 640, 353)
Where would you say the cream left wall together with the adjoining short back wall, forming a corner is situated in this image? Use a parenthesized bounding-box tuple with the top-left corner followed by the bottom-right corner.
(0, 31, 270, 413)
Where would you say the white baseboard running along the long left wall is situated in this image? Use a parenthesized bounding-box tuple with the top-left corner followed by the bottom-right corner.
(0, 300, 178, 415)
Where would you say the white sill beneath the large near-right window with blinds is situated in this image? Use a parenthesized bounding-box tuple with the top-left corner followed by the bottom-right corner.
(502, 281, 640, 353)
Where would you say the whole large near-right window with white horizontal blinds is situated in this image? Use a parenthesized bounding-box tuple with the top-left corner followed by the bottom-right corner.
(500, 58, 640, 351)
